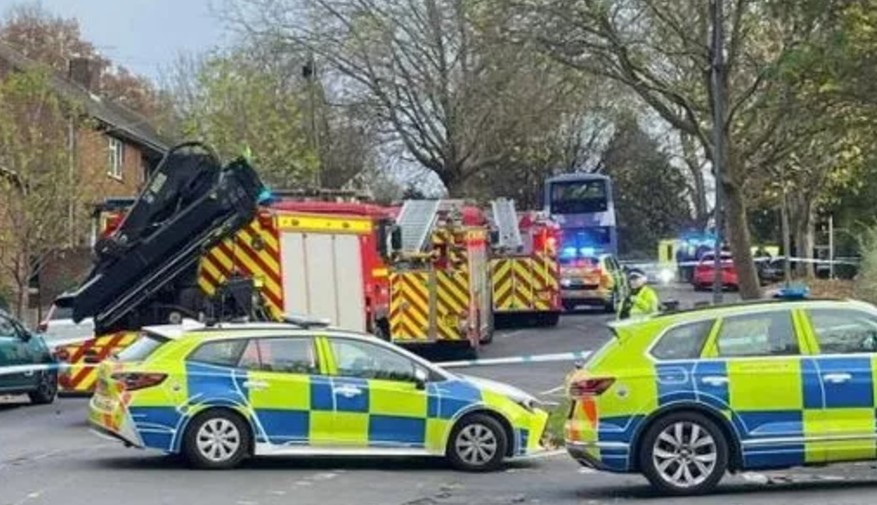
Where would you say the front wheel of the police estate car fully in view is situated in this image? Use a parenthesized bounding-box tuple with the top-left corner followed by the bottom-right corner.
(447, 414, 508, 472)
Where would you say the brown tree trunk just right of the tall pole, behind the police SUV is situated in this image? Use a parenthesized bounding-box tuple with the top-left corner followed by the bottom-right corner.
(722, 179, 761, 300)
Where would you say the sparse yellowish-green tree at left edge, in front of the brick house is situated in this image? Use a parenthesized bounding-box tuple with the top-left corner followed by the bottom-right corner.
(0, 71, 80, 317)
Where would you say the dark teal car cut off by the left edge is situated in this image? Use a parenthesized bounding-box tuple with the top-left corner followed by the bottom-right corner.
(0, 310, 58, 404)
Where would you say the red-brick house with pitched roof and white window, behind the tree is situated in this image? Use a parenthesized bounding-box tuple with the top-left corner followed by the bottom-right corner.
(0, 43, 171, 316)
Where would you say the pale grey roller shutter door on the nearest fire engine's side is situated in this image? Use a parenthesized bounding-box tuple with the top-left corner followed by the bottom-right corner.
(281, 231, 366, 331)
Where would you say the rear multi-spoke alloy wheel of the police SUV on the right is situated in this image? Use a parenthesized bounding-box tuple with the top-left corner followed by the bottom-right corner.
(639, 412, 728, 496)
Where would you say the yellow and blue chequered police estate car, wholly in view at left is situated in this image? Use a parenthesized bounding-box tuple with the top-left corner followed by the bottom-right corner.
(89, 323, 548, 471)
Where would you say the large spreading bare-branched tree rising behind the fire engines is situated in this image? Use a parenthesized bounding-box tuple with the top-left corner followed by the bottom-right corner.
(222, 0, 573, 195)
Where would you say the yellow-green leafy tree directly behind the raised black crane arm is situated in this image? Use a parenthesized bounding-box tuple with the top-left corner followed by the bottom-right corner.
(173, 49, 317, 188)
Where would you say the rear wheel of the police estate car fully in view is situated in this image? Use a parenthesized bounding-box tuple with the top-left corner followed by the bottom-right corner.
(183, 410, 250, 470)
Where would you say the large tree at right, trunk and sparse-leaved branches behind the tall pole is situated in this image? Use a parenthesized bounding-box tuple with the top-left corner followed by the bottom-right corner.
(512, 0, 840, 298)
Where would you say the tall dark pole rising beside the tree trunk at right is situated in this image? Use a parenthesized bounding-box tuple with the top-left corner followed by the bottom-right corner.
(712, 0, 725, 305)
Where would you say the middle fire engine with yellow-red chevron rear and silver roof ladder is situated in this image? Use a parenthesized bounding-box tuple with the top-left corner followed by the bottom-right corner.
(388, 200, 493, 351)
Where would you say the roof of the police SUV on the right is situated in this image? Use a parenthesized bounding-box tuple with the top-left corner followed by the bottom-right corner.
(609, 298, 877, 328)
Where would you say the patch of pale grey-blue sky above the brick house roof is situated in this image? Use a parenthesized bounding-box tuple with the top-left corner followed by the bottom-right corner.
(0, 0, 227, 80)
